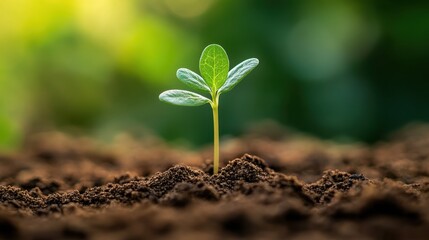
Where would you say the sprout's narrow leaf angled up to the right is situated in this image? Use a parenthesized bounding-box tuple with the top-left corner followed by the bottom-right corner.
(219, 58, 259, 94)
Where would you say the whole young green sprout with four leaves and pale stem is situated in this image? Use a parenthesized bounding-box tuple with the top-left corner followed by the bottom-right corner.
(159, 44, 259, 174)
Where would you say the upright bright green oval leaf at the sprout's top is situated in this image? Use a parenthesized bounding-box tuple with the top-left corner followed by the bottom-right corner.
(200, 44, 229, 92)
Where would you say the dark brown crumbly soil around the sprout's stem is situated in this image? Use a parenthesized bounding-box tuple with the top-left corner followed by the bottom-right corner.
(0, 125, 429, 240)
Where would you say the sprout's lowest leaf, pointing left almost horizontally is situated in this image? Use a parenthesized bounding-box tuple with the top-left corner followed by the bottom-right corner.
(159, 90, 211, 107)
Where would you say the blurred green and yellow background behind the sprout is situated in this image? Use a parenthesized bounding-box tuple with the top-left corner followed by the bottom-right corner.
(0, 0, 429, 149)
